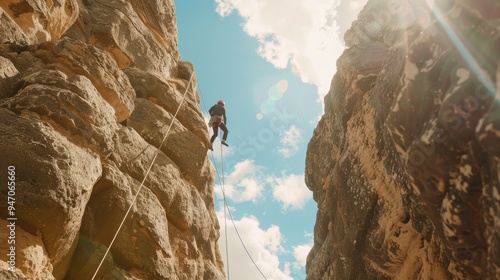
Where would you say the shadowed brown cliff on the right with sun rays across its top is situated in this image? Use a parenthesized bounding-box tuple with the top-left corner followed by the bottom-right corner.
(306, 0, 500, 279)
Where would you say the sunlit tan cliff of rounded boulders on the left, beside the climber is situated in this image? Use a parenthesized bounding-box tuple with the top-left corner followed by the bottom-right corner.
(0, 0, 225, 280)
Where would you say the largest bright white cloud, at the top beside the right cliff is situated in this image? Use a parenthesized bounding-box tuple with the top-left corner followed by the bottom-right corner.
(216, 0, 344, 96)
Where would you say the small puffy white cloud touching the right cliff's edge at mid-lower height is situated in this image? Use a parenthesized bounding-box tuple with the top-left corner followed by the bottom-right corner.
(268, 174, 312, 210)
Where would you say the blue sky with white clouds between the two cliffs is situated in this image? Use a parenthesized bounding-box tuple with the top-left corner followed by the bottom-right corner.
(175, 0, 366, 280)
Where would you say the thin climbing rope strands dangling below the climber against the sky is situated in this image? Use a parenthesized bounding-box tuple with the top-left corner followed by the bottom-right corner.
(198, 90, 267, 280)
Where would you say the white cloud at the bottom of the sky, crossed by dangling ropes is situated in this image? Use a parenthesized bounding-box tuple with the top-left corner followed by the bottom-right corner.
(217, 212, 292, 280)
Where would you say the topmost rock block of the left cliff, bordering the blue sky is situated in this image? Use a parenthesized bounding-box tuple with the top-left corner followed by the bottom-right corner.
(69, 0, 180, 77)
